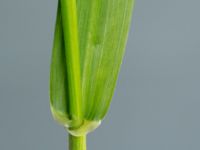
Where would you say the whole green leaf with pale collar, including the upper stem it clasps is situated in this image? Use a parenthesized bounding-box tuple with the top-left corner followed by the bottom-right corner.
(50, 0, 134, 136)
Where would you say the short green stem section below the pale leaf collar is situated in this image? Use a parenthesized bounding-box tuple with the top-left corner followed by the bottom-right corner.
(69, 134, 86, 150)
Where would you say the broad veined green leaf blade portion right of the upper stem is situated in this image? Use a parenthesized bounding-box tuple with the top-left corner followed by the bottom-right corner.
(78, 0, 134, 120)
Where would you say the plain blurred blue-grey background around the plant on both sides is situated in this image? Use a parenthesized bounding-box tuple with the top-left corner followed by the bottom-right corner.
(0, 0, 200, 150)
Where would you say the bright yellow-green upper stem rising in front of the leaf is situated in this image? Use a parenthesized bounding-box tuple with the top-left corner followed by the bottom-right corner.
(61, 0, 82, 120)
